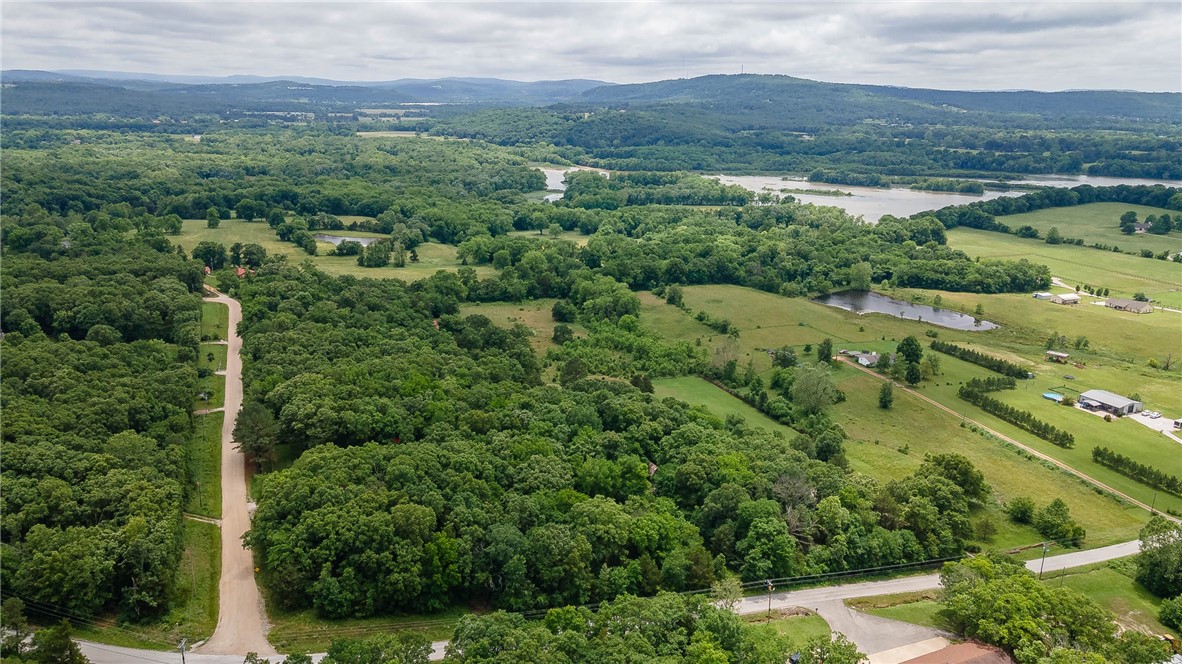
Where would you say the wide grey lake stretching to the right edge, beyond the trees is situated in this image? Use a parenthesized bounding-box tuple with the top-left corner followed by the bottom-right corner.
(709, 175, 1182, 222)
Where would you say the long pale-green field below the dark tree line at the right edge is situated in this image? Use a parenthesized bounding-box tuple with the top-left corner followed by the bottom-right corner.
(948, 228, 1182, 315)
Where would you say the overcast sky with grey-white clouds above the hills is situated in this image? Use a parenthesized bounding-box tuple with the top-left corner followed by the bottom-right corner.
(2, 0, 1182, 91)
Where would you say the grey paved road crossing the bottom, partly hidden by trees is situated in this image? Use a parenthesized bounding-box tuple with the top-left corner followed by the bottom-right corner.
(78, 541, 1141, 664)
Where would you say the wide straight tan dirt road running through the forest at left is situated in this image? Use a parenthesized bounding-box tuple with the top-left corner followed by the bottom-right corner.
(196, 288, 275, 657)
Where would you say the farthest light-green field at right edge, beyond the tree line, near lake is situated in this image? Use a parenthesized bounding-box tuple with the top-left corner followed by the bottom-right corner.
(998, 203, 1182, 254)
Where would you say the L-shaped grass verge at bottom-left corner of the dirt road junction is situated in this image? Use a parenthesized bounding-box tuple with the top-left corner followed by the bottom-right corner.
(73, 519, 221, 652)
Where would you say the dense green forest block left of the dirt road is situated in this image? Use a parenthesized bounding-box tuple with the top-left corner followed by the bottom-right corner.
(0, 220, 201, 619)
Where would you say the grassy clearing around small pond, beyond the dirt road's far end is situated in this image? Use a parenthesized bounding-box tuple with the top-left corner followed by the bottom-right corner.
(176, 216, 495, 281)
